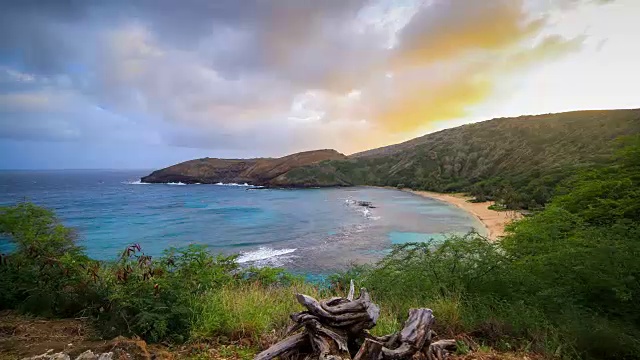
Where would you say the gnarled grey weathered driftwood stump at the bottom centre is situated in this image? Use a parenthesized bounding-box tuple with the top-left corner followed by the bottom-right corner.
(254, 281, 456, 360)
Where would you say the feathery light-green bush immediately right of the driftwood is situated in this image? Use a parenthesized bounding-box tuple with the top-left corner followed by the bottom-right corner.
(332, 234, 542, 345)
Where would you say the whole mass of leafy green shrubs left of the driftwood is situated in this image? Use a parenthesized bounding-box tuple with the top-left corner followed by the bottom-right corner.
(0, 203, 300, 343)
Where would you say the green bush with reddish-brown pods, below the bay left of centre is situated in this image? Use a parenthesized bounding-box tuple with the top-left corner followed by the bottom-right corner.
(98, 245, 237, 342)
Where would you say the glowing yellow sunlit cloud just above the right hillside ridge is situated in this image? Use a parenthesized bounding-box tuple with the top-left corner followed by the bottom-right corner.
(362, 35, 584, 132)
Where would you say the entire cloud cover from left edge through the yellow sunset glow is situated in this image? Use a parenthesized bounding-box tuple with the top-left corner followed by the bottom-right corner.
(0, 0, 604, 153)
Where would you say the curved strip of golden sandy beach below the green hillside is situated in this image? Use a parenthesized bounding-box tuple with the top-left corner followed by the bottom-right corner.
(403, 189, 522, 240)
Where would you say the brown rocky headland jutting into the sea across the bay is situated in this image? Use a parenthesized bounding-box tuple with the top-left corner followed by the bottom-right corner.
(140, 149, 350, 187)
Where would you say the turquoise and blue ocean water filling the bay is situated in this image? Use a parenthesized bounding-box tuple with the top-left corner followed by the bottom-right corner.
(0, 170, 484, 274)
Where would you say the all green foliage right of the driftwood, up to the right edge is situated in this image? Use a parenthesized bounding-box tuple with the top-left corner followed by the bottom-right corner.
(333, 137, 640, 359)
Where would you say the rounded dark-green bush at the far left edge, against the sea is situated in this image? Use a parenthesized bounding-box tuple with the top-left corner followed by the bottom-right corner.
(0, 203, 99, 316)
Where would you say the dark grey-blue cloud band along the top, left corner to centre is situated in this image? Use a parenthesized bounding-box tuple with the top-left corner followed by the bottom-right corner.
(0, 0, 366, 76)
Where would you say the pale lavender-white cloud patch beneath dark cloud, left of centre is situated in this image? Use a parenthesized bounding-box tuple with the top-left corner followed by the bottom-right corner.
(96, 23, 298, 129)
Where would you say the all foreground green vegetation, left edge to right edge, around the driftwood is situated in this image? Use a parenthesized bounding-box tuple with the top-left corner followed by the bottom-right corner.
(0, 137, 640, 359)
